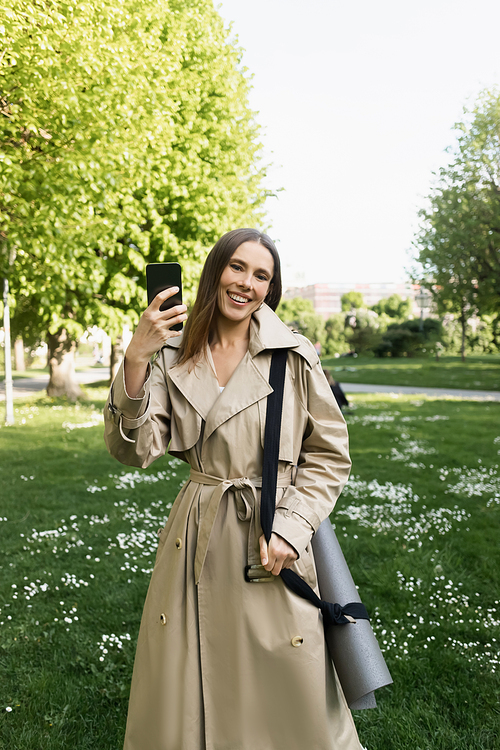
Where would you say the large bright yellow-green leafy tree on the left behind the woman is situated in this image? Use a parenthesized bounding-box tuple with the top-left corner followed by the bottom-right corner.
(0, 0, 266, 396)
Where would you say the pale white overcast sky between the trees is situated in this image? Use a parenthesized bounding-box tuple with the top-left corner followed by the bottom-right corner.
(215, 0, 500, 286)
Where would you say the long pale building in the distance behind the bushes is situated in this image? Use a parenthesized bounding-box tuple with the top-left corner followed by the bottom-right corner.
(283, 282, 420, 319)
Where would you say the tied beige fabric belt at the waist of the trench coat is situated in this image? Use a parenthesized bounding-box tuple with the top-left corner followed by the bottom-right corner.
(189, 469, 292, 584)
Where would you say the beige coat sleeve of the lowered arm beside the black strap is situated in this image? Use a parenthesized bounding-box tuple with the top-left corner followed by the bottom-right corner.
(273, 360, 351, 556)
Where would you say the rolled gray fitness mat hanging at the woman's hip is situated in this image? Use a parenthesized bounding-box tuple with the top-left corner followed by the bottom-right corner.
(312, 518, 392, 710)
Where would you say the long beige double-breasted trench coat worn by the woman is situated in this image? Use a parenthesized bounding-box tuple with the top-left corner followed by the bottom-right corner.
(105, 306, 361, 750)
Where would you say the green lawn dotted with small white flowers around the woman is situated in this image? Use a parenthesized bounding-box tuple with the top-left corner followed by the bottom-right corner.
(0, 388, 500, 750)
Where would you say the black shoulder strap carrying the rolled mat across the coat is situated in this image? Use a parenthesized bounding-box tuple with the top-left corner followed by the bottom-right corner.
(260, 349, 370, 625)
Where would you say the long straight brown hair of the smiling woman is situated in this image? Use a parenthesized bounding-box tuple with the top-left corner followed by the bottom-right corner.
(178, 229, 281, 364)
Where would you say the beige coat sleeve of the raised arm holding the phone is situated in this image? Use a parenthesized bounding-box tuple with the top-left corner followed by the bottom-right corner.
(104, 359, 171, 468)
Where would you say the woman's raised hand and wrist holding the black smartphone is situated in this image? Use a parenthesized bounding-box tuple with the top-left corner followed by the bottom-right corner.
(125, 287, 187, 398)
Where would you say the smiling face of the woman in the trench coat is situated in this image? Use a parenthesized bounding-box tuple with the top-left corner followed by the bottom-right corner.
(217, 242, 274, 323)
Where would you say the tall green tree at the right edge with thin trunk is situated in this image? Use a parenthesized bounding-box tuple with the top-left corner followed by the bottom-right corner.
(414, 90, 500, 359)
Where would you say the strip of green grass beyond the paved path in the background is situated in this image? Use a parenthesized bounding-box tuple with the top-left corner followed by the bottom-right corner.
(322, 354, 500, 391)
